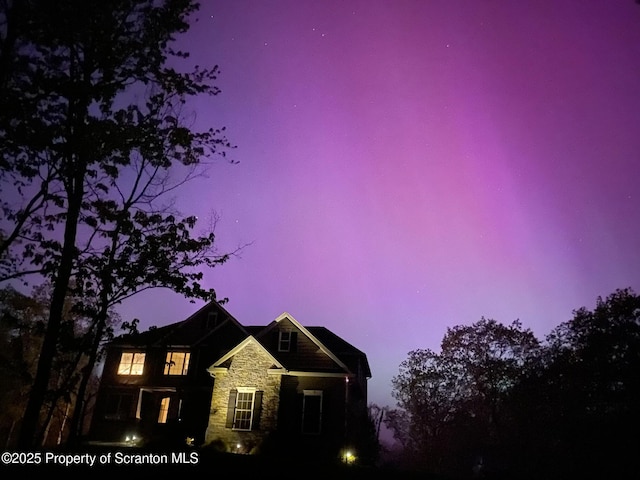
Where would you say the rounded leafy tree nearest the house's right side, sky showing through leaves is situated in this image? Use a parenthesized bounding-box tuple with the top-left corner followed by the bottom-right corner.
(389, 318, 539, 471)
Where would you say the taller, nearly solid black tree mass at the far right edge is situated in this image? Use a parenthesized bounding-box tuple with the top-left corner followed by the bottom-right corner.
(512, 288, 640, 475)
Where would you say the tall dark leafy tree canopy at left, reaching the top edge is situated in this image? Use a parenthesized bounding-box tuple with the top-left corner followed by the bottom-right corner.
(0, 0, 238, 447)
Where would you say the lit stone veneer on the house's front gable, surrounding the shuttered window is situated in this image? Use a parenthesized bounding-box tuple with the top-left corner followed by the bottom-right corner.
(205, 342, 281, 453)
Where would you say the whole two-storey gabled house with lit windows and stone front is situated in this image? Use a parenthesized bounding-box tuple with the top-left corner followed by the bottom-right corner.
(89, 302, 371, 462)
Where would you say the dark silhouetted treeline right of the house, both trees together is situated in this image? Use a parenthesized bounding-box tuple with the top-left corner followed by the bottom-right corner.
(384, 288, 640, 479)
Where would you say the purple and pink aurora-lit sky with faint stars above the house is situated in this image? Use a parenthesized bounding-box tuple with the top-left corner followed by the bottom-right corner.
(120, 0, 640, 412)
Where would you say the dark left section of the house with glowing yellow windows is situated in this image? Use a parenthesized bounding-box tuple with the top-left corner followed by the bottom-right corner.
(89, 302, 248, 443)
